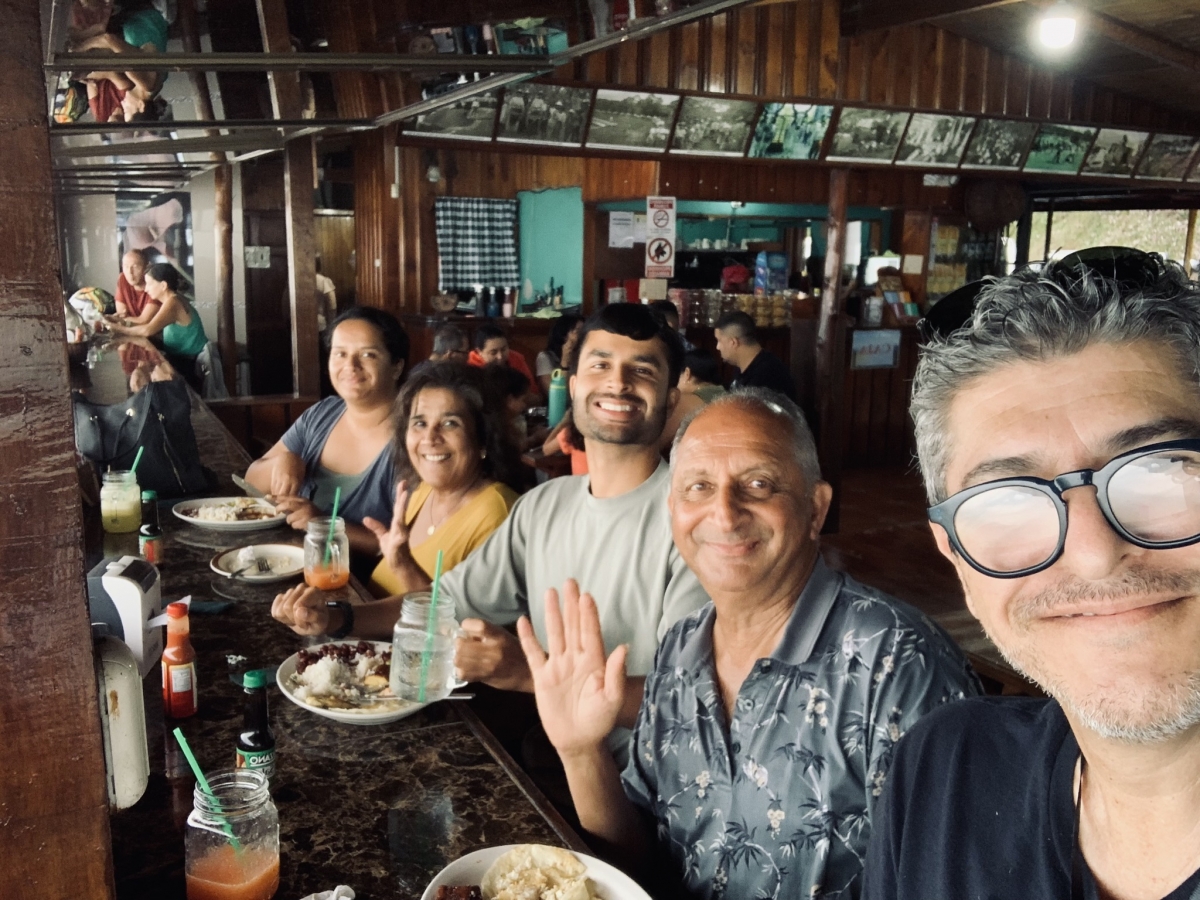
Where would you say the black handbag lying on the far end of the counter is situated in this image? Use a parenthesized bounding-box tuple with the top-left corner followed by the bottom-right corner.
(72, 379, 216, 497)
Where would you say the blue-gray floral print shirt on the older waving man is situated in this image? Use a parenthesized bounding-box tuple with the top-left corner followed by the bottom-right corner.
(623, 559, 979, 900)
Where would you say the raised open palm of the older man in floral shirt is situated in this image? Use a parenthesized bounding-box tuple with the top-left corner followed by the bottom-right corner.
(517, 580, 629, 757)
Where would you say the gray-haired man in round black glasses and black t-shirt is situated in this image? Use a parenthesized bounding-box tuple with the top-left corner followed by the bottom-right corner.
(863, 248, 1200, 900)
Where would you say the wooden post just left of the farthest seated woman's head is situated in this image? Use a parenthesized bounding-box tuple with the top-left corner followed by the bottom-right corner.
(283, 138, 316, 397)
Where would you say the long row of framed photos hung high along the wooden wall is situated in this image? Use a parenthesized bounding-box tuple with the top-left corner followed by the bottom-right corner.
(404, 83, 1200, 181)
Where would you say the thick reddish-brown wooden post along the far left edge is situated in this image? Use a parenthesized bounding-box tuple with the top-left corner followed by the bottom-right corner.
(0, 0, 118, 900)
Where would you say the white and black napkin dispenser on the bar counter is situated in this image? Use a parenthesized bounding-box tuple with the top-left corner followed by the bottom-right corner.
(88, 557, 162, 678)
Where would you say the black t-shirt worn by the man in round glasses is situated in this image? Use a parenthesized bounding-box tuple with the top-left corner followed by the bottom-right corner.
(862, 697, 1200, 900)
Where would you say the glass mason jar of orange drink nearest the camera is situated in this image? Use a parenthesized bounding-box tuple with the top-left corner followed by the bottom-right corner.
(184, 769, 280, 900)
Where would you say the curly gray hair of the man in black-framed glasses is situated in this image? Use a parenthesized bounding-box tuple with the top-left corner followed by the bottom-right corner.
(908, 257, 1200, 505)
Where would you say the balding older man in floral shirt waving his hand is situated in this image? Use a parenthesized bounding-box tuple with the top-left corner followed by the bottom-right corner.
(518, 389, 976, 898)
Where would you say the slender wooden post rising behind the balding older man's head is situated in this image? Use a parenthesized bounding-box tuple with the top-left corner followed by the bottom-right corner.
(816, 169, 850, 534)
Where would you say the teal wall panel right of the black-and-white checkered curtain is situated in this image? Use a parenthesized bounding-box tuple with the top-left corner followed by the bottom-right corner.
(517, 187, 583, 306)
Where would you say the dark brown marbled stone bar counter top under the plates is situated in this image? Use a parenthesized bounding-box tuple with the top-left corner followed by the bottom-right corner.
(83, 343, 587, 900)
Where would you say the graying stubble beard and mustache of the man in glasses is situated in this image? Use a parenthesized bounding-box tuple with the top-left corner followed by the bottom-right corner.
(964, 568, 1200, 744)
